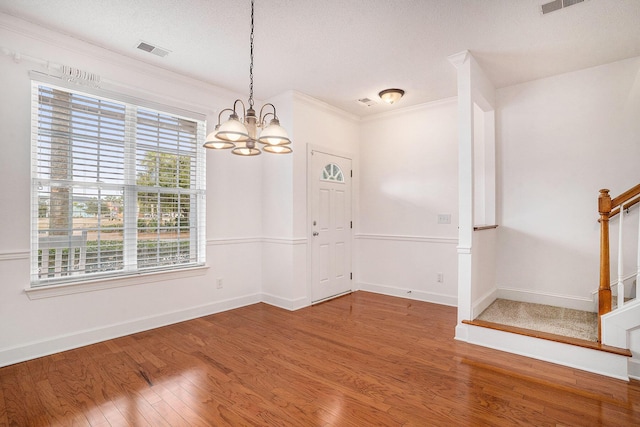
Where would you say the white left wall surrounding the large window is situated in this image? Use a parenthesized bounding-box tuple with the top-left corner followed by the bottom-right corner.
(0, 14, 262, 366)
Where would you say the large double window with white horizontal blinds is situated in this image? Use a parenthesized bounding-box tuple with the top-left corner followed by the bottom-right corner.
(31, 81, 205, 287)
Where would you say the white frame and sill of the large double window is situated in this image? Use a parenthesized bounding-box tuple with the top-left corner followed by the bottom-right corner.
(27, 77, 206, 290)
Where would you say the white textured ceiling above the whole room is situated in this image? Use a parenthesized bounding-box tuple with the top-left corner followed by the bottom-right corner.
(0, 0, 640, 116)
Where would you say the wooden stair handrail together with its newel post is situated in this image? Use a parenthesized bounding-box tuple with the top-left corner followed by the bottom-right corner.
(598, 184, 640, 342)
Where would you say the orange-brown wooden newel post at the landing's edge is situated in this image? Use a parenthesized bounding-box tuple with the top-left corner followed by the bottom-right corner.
(598, 189, 611, 342)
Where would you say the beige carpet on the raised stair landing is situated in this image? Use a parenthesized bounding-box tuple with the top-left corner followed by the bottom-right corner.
(478, 299, 598, 341)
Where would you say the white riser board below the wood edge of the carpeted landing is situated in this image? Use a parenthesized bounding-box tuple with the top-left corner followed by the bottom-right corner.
(456, 324, 629, 381)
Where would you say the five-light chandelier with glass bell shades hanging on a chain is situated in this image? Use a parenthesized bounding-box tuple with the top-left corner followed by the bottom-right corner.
(203, 0, 293, 156)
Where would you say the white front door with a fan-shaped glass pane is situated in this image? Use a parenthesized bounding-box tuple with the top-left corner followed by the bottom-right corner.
(310, 151, 352, 302)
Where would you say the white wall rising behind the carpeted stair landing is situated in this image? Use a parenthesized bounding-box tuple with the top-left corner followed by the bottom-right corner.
(497, 58, 640, 309)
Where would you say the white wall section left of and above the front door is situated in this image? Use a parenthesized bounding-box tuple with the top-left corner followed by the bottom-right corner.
(261, 92, 359, 309)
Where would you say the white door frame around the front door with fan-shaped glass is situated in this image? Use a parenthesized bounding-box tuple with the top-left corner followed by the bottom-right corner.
(306, 144, 355, 306)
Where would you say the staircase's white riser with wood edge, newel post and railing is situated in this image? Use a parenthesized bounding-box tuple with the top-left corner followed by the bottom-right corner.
(462, 184, 640, 380)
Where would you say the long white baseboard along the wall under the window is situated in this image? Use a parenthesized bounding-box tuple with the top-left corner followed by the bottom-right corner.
(0, 294, 261, 367)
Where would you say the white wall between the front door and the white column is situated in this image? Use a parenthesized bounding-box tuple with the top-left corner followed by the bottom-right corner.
(356, 99, 458, 305)
